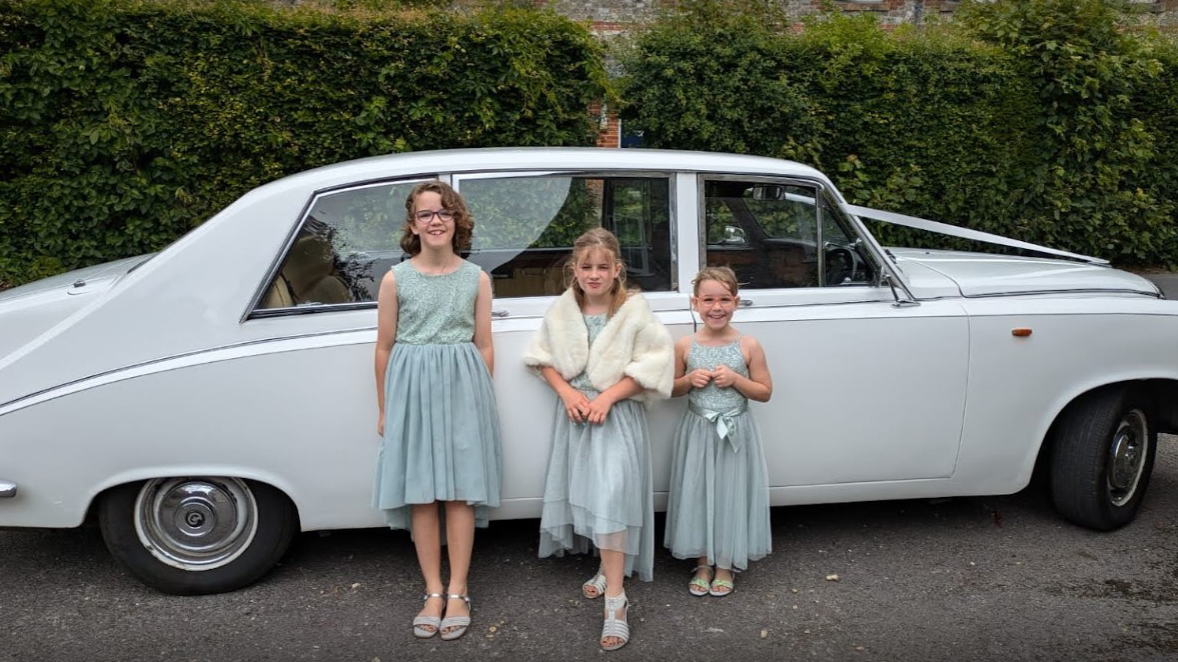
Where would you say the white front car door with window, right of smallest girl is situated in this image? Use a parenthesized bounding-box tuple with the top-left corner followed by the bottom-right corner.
(697, 176, 968, 490)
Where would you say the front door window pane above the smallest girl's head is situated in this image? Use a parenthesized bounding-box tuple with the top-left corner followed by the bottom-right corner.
(703, 179, 820, 289)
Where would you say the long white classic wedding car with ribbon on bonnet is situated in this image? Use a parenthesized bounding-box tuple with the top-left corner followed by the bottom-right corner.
(0, 148, 1178, 594)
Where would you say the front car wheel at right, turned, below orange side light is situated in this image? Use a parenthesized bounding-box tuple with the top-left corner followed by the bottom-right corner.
(1051, 388, 1158, 531)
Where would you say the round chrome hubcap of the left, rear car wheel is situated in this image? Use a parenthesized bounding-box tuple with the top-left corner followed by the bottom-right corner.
(135, 477, 258, 570)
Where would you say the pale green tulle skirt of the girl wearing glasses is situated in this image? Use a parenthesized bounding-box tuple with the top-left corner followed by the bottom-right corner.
(372, 343, 503, 529)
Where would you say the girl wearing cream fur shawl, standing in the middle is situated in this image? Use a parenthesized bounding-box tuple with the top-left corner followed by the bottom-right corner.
(524, 227, 674, 650)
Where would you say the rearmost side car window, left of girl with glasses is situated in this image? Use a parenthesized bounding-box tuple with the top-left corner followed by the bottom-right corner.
(258, 179, 424, 309)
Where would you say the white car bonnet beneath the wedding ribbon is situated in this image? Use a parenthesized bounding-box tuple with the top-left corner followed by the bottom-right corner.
(888, 249, 1160, 297)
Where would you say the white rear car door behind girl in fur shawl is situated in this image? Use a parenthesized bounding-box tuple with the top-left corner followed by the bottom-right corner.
(452, 170, 694, 517)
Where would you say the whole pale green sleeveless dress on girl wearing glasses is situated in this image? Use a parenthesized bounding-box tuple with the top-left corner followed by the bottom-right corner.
(372, 260, 502, 529)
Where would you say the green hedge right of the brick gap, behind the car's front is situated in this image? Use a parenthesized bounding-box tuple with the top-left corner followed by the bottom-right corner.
(620, 0, 1178, 265)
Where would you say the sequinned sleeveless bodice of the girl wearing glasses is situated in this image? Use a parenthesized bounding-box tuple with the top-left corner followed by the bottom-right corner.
(392, 260, 482, 345)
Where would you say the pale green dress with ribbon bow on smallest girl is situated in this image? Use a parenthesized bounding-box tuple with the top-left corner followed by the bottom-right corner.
(663, 338, 773, 570)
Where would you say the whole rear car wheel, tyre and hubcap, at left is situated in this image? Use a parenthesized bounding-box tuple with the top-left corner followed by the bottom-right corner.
(99, 476, 298, 595)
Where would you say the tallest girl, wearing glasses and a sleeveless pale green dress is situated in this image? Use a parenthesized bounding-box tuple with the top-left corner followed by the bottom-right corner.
(373, 181, 502, 640)
